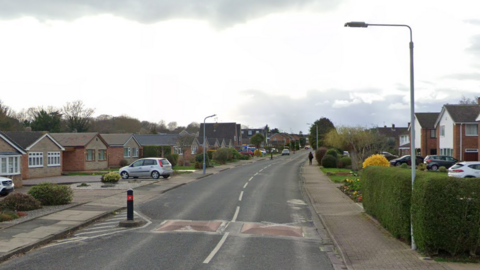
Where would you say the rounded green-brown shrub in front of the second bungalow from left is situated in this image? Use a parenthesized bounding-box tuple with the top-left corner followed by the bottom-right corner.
(28, 183, 73, 205)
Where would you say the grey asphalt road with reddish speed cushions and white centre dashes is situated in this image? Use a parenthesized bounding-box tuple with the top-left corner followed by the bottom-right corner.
(0, 154, 333, 269)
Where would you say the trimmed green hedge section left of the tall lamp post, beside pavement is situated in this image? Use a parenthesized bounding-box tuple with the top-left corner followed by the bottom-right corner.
(361, 166, 412, 243)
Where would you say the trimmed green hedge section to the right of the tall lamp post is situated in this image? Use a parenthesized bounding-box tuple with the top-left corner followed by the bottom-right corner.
(412, 173, 480, 256)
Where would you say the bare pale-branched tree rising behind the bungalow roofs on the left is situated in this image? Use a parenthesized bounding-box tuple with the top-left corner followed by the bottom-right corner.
(62, 100, 95, 132)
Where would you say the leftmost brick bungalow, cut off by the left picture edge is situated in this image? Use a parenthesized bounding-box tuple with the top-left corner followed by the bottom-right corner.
(0, 132, 27, 187)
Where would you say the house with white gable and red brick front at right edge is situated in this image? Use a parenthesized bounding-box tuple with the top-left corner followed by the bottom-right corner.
(435, 100, 480, 161)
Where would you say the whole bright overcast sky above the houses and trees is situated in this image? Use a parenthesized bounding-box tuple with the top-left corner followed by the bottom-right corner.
(0, 0, 480, 133)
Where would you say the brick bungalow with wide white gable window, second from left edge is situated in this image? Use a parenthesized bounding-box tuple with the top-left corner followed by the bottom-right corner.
(4, 131, 65, 180)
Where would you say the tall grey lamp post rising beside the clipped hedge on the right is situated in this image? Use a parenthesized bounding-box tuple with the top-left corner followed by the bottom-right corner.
(345, 22, 417, 250)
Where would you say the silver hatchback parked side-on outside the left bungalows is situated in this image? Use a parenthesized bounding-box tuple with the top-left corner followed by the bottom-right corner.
(119, 158, 173, 179)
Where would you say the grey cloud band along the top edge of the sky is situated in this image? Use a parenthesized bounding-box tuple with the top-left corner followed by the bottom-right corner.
(0, 0, 343, 27)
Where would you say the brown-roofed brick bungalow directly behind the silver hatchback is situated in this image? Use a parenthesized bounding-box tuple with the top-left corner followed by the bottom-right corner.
(100, 133, 142, 168)
